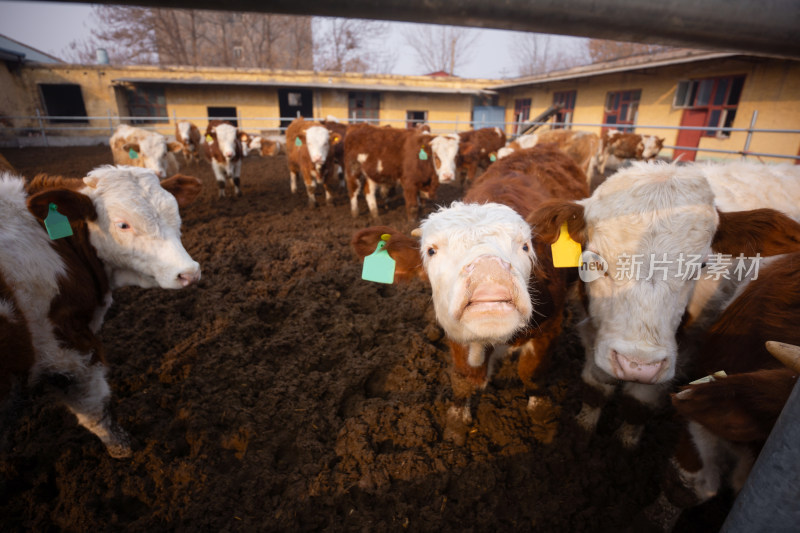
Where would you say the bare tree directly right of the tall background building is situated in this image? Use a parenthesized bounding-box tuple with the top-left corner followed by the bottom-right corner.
(314, 17, 397, 72)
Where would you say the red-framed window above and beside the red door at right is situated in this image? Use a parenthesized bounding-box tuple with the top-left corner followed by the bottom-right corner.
(672, 76, 744, 137)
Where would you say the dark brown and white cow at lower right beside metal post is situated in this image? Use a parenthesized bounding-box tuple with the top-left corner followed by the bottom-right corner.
(646, 252, 800, 529)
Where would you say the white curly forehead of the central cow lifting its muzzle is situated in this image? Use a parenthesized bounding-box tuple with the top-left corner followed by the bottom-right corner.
(420, 202, 531, 252)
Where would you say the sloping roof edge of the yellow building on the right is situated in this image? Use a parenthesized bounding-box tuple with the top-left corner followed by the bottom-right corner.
(492, 48, 742, 90)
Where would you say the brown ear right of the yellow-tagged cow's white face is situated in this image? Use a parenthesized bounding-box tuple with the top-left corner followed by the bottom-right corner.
(711, 209, 800, 257)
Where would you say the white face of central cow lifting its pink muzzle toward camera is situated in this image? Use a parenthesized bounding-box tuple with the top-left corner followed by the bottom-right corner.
(420, 202, 534, 344)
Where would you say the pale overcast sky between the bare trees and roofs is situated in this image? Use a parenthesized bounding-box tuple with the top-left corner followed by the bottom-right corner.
(0, 1, 575, 78)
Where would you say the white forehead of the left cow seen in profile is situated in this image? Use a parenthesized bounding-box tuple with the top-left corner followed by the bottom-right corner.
(87, 165, 181, 234)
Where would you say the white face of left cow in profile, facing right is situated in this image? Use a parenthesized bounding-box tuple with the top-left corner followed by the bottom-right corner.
(80, 166, 200, 289)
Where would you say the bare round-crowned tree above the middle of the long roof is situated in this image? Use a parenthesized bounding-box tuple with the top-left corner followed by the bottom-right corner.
(402, 24, 480, 76)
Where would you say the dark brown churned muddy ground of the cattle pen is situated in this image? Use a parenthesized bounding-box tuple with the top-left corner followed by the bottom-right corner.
(0, 147, 730, 533)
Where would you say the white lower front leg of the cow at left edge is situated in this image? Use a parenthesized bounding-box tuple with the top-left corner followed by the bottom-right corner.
(64, 363, 131, 458)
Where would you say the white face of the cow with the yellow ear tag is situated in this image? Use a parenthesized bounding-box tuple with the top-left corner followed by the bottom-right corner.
(580, 163, 719, 383)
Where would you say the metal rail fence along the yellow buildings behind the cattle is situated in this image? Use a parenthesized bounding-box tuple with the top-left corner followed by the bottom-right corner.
(0, 109, 800, 161)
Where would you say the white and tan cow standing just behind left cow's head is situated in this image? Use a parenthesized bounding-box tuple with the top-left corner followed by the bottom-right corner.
(109, 124, 182, 179)
